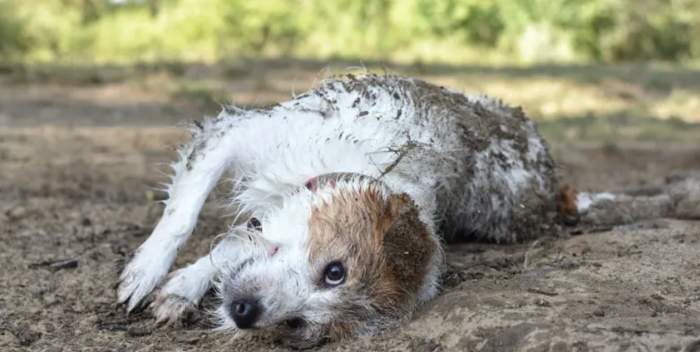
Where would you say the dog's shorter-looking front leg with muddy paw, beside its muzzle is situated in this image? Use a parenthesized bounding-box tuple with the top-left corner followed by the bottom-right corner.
(151, 227, 241, 325)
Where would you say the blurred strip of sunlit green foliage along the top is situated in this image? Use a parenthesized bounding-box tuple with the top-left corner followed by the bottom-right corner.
(0, 0, 700, 62)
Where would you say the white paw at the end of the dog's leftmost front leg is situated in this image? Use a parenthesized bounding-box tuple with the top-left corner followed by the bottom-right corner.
(117, 244, 171, 312)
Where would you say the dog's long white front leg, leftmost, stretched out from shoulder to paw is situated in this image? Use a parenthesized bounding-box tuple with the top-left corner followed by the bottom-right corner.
(117, 124, 237, 311)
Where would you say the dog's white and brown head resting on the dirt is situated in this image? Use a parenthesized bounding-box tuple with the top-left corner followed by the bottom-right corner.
(217, 177, 440, 340)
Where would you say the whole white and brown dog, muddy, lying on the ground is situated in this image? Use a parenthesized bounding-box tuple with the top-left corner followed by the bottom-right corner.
(112, 73, 700, 340)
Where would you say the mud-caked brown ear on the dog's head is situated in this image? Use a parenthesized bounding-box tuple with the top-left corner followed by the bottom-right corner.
(382, 193, 438, 293)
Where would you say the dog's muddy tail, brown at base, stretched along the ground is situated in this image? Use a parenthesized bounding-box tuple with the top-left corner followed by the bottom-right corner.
(557, 174, 700, 226)
